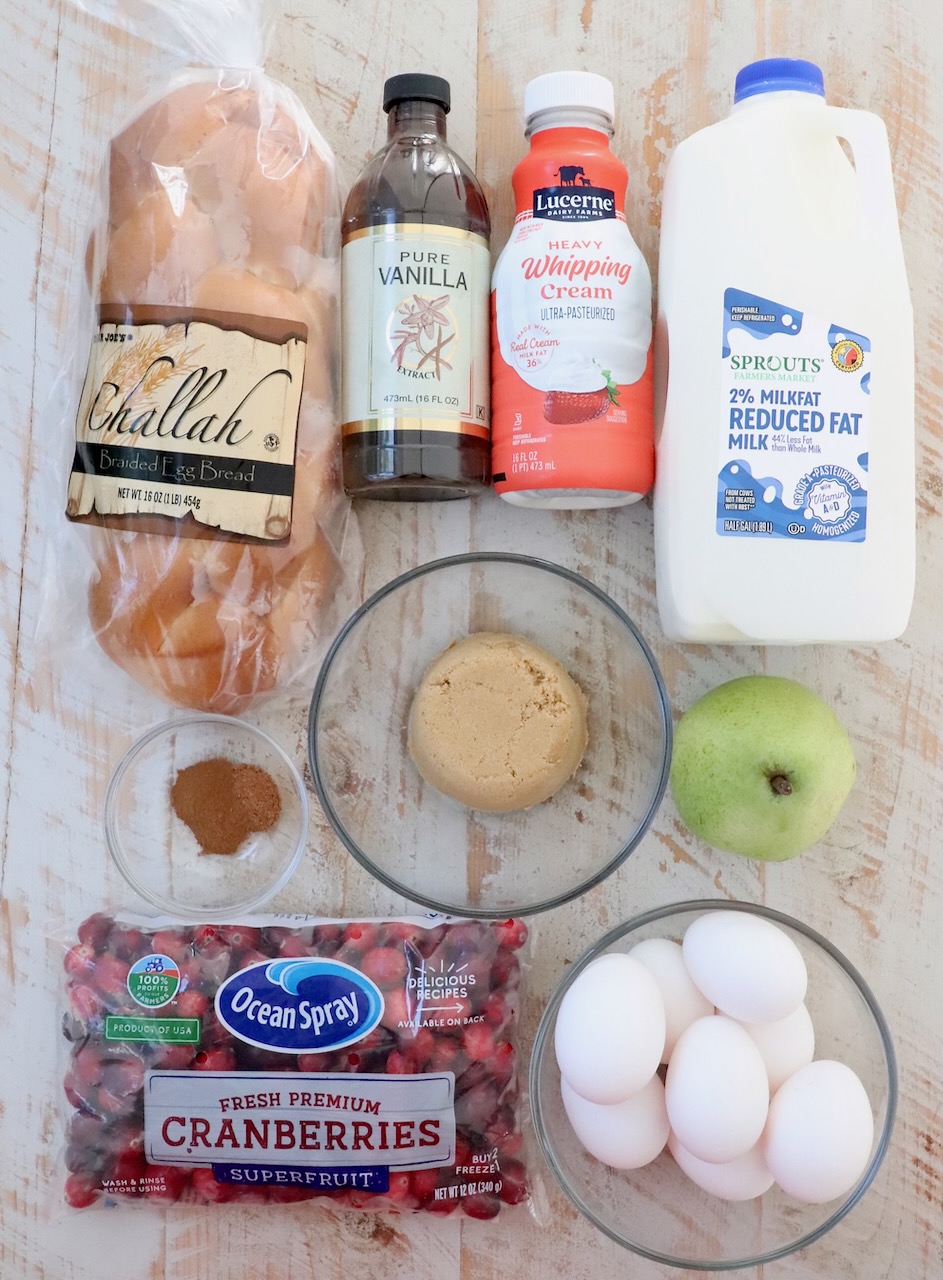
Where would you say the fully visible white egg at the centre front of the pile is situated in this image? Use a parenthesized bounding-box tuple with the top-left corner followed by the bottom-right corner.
(665, 1014, 769, 1165)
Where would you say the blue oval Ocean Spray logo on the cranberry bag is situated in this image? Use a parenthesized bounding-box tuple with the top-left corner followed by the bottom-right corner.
(216, 959, 384, 1053)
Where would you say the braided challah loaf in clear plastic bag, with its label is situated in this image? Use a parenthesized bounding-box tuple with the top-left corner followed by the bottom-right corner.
(59, 0, 361, 713)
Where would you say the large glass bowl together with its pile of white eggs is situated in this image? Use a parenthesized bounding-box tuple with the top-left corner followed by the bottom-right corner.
(530, 901, 897, 1271)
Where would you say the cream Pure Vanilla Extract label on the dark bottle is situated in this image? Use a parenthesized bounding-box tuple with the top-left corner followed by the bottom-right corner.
(343, 230, 491, 439)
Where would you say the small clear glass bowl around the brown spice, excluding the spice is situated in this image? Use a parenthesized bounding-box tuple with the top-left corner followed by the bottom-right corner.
(105, 716, 308, 920)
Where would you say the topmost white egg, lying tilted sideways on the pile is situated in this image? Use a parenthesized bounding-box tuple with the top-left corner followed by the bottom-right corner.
(682, 911, 809, 1023)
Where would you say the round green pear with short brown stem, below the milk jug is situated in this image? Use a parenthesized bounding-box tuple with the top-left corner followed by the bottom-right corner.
(672, 676, 855, 863)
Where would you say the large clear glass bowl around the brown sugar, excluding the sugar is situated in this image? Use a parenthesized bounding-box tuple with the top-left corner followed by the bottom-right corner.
(308, 553, 670, 916)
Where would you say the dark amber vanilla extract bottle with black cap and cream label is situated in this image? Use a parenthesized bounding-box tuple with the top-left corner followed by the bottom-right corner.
(342, 76, 491, 500)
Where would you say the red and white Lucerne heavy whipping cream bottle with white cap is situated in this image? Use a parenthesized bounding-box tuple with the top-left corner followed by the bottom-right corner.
(491, 72, 654, 508)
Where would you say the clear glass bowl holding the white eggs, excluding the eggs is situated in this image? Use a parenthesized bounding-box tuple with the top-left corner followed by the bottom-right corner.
(530, 901, 897, 1271)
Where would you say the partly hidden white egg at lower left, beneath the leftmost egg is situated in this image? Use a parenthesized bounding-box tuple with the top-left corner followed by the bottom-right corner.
(560, 1075, 668, 1169)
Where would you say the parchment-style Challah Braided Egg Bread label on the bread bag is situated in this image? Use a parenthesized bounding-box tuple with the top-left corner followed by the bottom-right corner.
(67, 305, 307, 543)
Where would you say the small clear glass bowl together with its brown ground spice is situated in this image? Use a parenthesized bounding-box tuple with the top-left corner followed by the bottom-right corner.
(105, 716, 308, 920)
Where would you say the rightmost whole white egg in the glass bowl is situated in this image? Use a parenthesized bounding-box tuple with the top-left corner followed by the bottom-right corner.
(763, 1059, 874, 1204)
